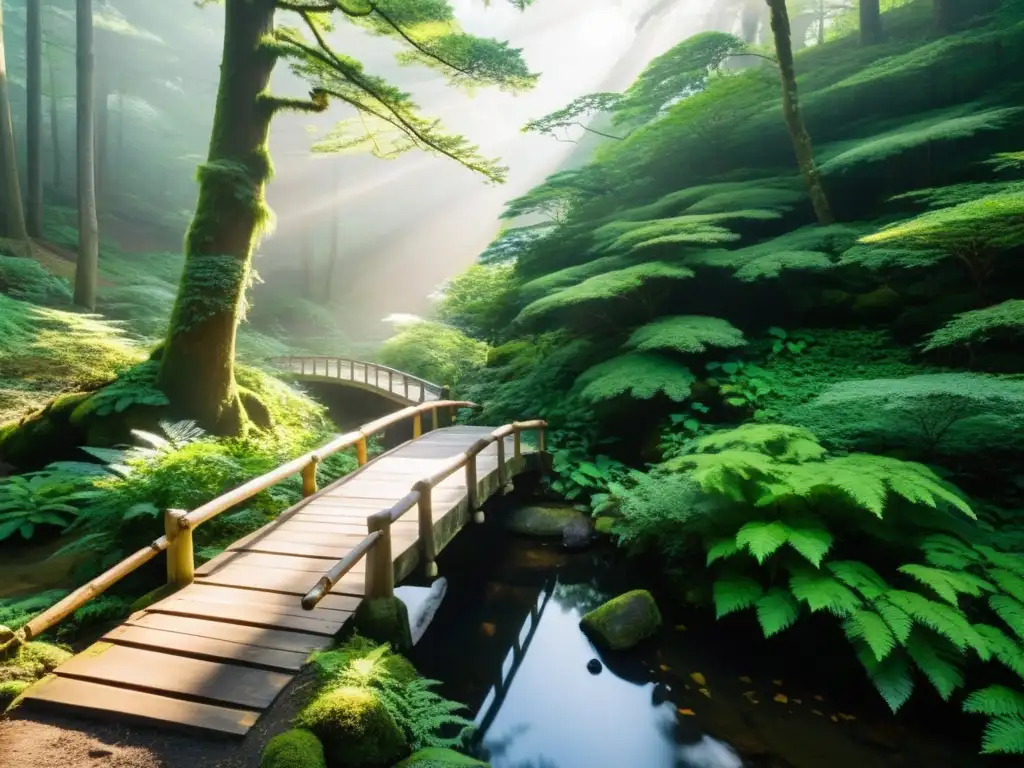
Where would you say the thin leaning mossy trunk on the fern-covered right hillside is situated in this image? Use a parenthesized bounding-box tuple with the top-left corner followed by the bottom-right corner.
(766, 0, 836, 224)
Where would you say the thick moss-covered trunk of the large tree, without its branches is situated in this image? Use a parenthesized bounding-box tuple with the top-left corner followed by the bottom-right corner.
(158, 0, 276, 434)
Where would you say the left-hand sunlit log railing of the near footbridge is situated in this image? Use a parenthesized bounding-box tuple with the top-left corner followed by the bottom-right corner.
(14, 400, 477, 642)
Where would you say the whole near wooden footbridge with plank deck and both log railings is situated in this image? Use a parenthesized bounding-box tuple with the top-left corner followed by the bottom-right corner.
(8, 376, 546, 736)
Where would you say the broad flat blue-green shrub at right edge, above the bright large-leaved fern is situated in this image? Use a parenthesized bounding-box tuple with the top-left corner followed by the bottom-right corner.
(792, 374, 1024, 457)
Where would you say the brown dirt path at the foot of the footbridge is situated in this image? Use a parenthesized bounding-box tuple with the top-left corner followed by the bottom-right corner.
(0, 671, 312, 768)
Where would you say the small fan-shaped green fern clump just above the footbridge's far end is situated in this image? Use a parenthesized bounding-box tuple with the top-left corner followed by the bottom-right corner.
(577, 352, 696, 402)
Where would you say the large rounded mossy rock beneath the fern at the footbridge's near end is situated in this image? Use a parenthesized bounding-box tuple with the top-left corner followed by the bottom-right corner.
(294, 686, 410, 768)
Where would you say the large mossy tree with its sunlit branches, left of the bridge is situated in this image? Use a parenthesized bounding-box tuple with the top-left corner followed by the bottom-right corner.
(158, 0, 537, 434)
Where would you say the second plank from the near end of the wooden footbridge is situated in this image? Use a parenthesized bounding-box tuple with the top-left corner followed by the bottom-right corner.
(57, 643, 292, 710)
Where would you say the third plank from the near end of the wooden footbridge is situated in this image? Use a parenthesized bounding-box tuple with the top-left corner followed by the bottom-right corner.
(100, 625, 307, 672)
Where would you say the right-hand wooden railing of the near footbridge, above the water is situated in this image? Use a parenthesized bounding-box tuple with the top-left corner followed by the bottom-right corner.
(302, 419, 548, 610)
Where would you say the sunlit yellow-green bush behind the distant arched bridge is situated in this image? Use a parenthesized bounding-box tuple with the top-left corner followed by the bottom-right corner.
(377, 321, 487, 386)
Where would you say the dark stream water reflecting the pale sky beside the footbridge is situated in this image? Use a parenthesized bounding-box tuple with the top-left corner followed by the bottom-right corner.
(414, 505, 1013, 768)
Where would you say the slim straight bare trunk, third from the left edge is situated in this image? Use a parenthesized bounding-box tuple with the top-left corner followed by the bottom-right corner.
(75, 0, 99, 310)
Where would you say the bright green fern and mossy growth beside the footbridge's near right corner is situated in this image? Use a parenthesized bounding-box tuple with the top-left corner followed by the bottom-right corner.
(296, 635, 472, 757)
